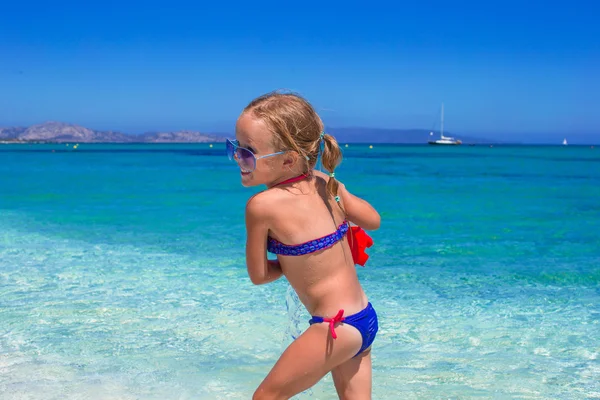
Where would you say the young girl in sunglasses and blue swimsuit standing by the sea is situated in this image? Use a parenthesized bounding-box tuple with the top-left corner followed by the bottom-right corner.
(227, 93, 380, 400)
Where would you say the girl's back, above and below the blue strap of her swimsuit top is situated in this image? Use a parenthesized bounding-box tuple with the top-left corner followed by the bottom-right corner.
(259, 174, 367, 315)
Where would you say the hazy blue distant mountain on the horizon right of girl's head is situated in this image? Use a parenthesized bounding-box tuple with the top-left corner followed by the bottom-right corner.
(326, 128, 500, 144)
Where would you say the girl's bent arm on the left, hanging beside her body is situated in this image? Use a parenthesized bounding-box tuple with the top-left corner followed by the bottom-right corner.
(246, 195, 283, 285)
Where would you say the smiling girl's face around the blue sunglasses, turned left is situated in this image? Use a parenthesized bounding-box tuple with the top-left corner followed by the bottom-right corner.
(235, 113, 284, 186)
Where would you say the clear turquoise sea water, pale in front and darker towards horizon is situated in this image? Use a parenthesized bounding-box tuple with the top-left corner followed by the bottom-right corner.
(0, 144, 600, 399)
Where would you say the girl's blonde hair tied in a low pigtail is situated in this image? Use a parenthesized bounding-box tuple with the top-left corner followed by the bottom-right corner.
(243, 91, 342, 200)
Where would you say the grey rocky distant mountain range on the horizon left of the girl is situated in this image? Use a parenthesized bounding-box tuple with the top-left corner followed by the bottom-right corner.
(0, 121, 224, 143)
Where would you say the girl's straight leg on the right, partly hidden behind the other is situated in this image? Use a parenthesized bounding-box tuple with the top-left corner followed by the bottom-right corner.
(331, 348, 372, 400)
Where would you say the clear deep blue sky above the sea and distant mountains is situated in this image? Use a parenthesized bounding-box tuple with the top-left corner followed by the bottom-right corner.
(0, 0, 600, 142)
